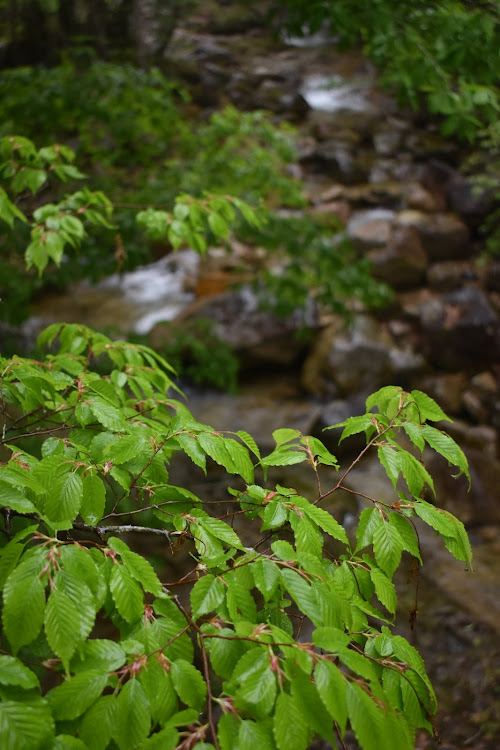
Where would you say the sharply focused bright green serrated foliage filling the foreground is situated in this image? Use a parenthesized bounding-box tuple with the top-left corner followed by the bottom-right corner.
(0, 325, 471, 750)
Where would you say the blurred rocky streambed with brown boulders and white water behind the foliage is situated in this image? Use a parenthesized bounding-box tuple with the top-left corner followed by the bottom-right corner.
(15, 4, 500, 750)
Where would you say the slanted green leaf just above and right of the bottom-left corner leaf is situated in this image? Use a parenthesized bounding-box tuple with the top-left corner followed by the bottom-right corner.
(47, 670, 108, 721)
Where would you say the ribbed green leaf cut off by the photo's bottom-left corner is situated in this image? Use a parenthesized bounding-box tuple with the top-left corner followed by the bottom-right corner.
(0, 701, 54, 750)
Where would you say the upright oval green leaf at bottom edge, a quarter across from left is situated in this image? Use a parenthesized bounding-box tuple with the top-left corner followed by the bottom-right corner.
(113, 679, 151, 750)
